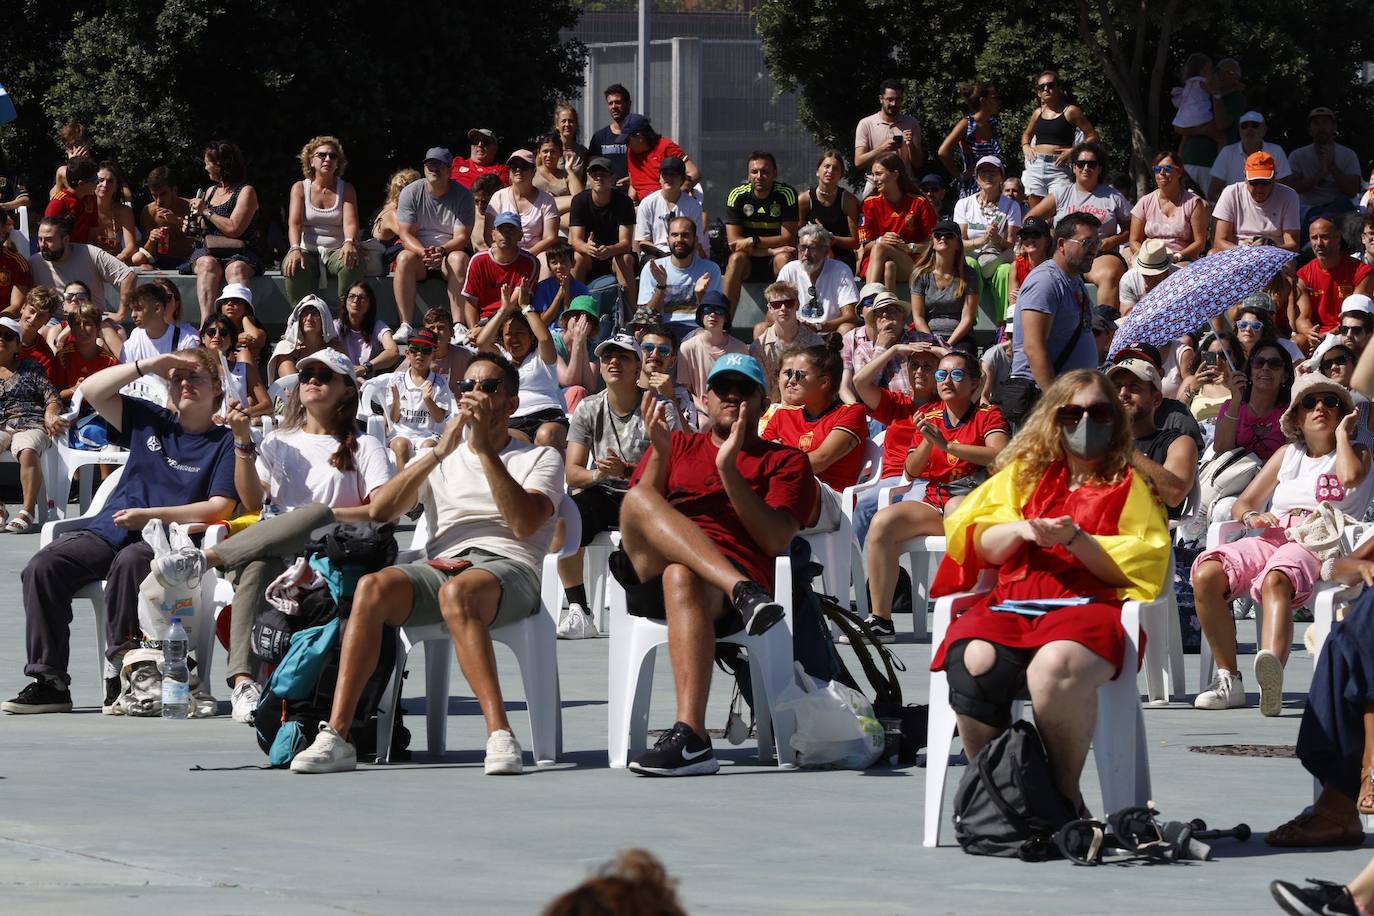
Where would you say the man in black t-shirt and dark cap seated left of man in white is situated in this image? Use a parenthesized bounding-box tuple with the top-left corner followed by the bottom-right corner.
(567, 157, 638, 302)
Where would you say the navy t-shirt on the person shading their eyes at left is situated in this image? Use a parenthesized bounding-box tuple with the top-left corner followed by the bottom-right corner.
(79, 396, 239, 548)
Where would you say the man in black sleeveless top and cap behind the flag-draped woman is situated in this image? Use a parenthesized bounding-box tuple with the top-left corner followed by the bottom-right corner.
(1107, 357, 1198, 519)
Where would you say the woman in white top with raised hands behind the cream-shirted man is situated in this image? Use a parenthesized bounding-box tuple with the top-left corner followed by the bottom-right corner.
(477, 286, 567, 452)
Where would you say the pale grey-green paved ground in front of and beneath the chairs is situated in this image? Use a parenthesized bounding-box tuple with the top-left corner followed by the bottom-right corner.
(0, 513, 1369, 915)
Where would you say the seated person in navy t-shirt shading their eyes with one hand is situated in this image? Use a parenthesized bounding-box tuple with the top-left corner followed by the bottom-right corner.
(0, 351, 239, 715)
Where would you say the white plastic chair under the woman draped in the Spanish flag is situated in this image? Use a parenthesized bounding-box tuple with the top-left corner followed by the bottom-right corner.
(922, 574, 1164, 846)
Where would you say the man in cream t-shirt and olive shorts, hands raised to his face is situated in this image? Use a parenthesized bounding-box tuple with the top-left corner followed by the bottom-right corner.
(291, 353, 563, 775)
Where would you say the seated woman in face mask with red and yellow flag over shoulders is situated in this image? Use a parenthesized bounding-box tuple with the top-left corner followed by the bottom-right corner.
(930, 369, 1169, 806)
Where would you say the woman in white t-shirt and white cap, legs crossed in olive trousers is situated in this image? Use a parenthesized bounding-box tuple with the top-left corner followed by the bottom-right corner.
(159, 349, 392, 722)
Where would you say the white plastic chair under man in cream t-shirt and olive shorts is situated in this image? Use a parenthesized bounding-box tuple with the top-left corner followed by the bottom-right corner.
(376, 493, 581, 766)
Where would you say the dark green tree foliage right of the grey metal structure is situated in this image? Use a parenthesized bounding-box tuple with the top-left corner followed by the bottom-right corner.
(756, 0, 1374, 189)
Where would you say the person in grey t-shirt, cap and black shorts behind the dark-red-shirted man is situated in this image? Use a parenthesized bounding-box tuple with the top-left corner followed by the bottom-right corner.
(558, 334, 670, 639)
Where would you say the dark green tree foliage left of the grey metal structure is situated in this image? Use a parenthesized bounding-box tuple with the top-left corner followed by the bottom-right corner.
(0, 0, 585, 216)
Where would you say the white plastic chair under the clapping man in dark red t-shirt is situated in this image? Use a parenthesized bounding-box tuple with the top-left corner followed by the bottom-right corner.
(606, 556, 797, 769)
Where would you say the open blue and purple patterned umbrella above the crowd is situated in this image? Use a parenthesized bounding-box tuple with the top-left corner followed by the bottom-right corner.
(1112, 244, 1297, 356)
